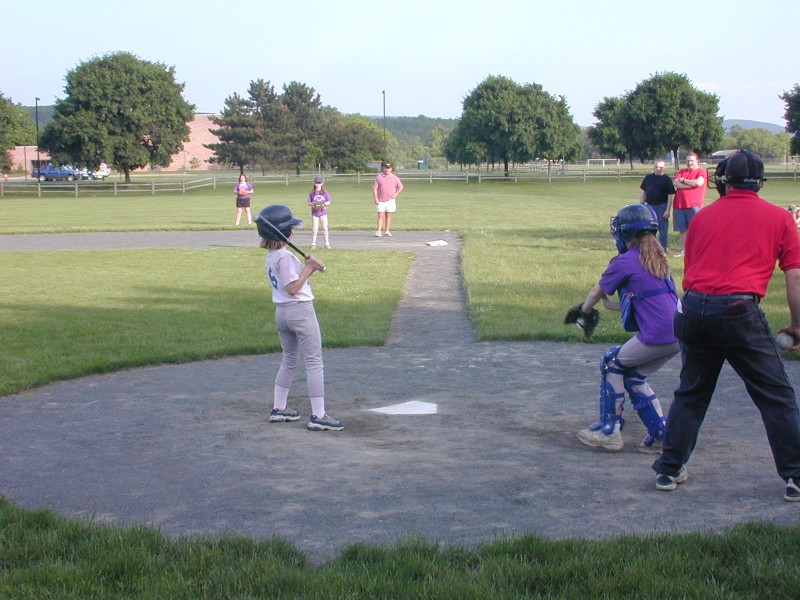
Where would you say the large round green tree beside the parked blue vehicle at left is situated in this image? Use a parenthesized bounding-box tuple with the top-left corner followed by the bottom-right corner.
(40, 52, 194, 182)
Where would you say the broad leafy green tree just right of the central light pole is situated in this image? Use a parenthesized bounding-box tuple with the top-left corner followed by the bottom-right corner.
(446, 76, 580, 176)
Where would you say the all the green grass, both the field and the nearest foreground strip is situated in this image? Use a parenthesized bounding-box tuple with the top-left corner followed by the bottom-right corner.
(0, 180, 800, 598)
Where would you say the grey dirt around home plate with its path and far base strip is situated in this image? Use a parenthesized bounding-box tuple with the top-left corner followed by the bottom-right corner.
(0, 230, 800, 561)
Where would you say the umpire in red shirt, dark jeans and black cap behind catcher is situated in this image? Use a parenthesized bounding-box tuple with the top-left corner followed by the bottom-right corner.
(653, 150, 800, 502)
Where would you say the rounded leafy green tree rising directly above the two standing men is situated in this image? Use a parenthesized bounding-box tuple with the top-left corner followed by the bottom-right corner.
(620, 73, 724, 164)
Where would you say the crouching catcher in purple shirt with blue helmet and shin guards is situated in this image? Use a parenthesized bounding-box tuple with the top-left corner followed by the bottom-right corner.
(564, 204, 680, 452)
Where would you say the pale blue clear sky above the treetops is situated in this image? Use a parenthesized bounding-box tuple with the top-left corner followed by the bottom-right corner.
(0, 0, 800, 126)
